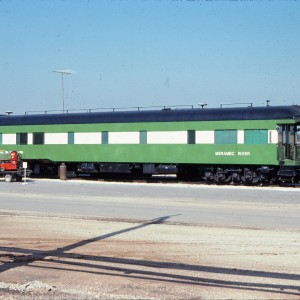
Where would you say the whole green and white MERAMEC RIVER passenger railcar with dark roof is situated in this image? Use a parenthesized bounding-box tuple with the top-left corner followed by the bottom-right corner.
(0, 106, 300, 183)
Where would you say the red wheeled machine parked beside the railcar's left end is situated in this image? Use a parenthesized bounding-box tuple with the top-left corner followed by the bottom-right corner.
(0, 150, 31, 182)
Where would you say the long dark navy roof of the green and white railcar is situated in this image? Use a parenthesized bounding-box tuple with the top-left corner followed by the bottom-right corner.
(0, 105, 300, 126)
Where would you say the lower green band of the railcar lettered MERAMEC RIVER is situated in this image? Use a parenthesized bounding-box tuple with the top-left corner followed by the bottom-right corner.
(2, 144, 278, 165)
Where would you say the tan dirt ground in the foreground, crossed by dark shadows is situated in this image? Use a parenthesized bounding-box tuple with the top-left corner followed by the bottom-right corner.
(0, 211, 300, 300)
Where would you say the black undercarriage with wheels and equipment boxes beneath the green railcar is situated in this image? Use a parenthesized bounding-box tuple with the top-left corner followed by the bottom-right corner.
(27, 161, 290, 185)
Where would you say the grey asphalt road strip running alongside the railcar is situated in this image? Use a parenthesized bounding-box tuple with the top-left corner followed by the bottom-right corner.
(0, 179, 300, 229)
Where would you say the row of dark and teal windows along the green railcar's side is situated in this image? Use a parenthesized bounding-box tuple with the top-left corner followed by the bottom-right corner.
(0, 129, 268, 145)
